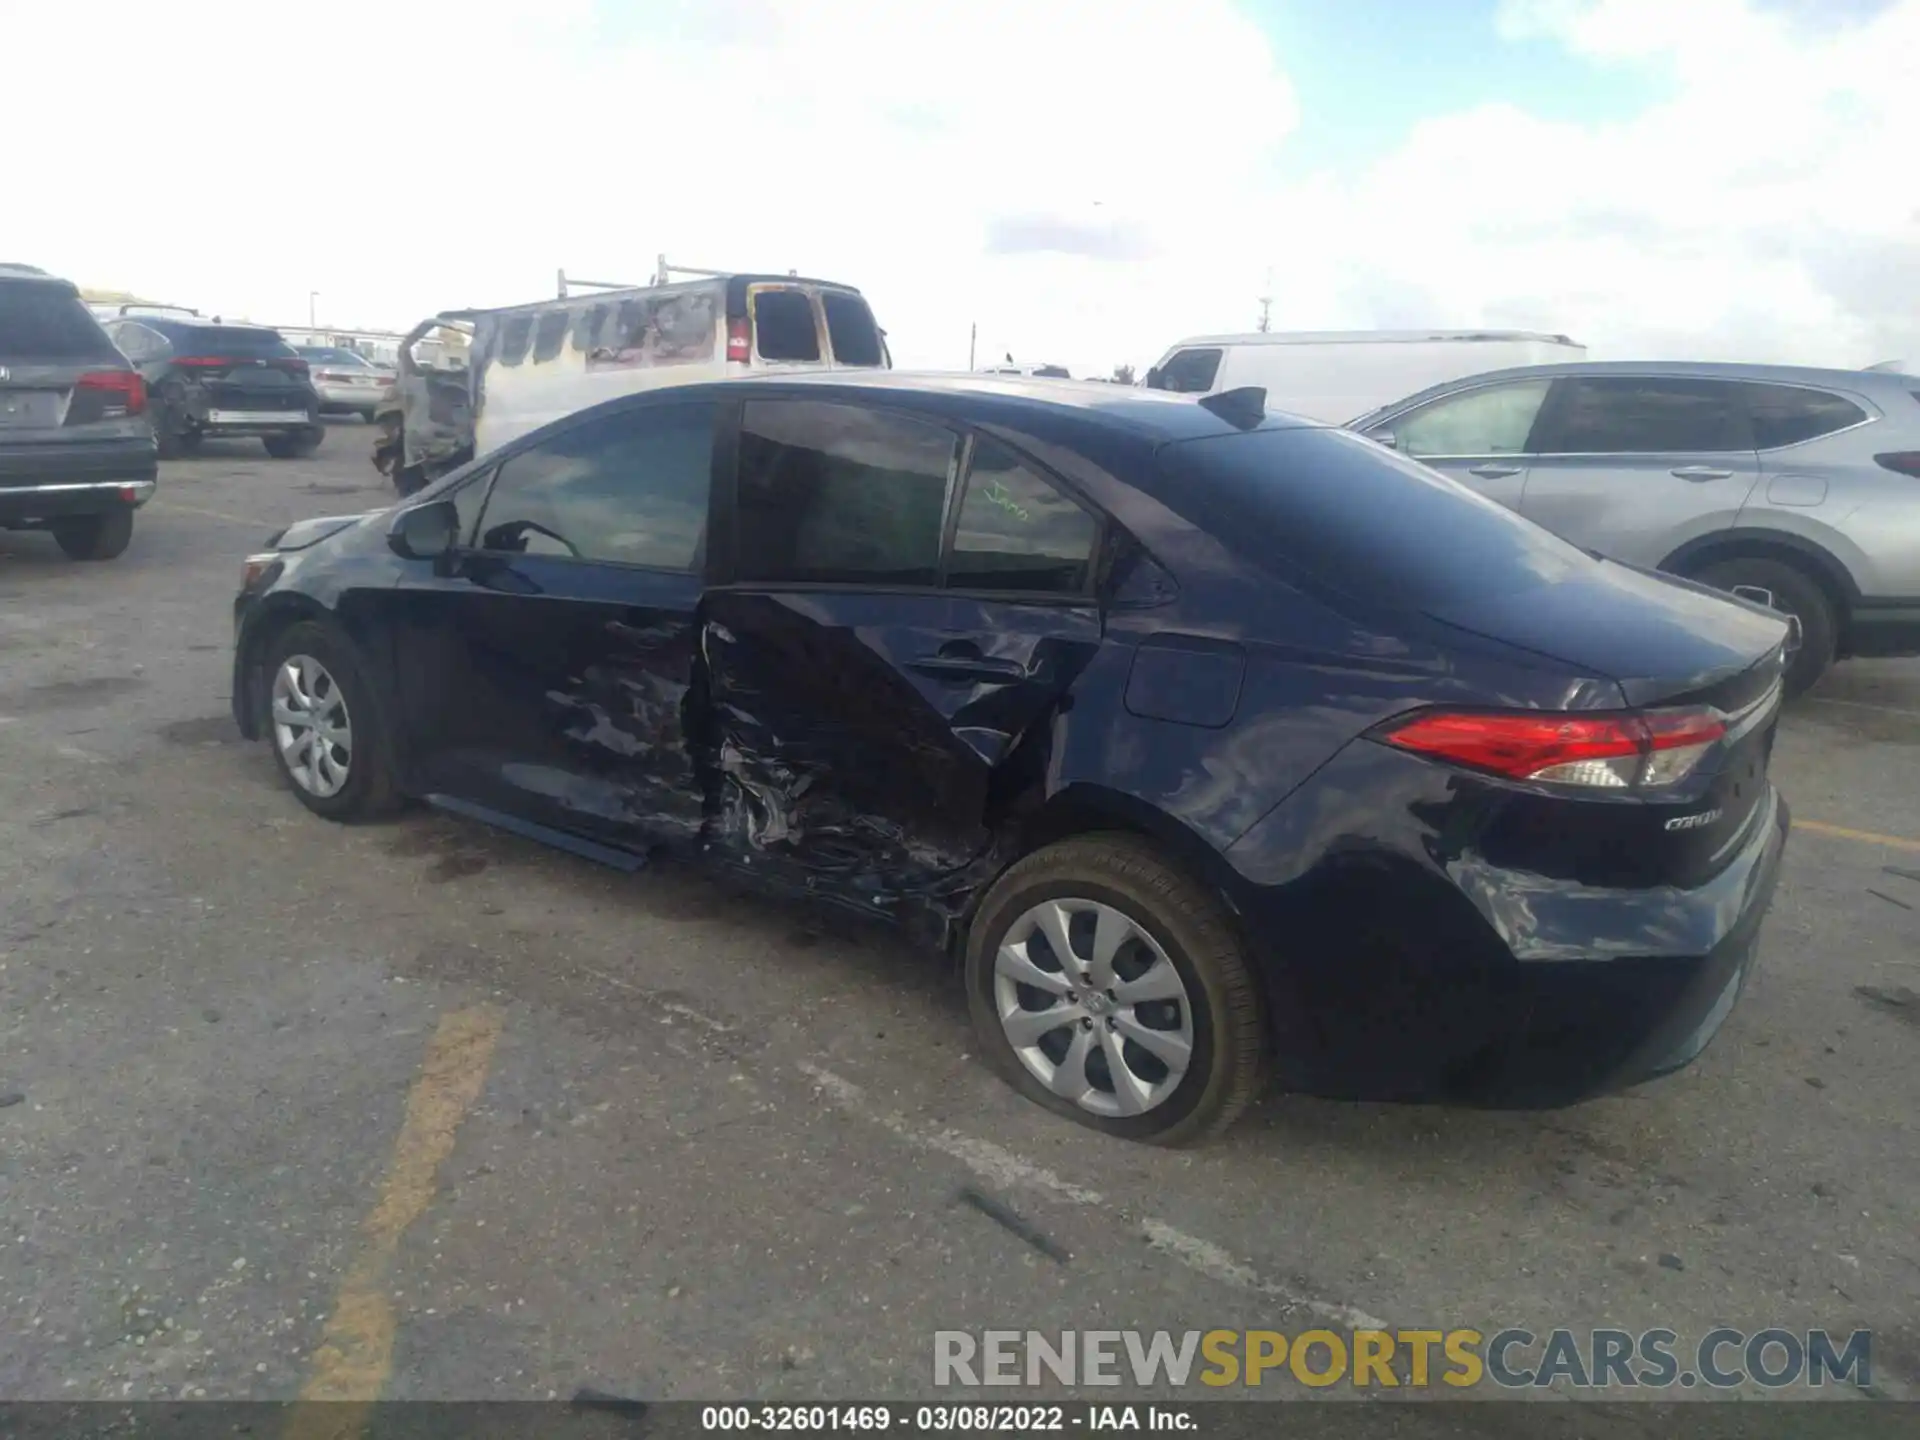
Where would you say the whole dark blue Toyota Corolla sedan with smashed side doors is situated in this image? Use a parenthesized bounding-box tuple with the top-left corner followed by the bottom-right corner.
(234, 372, 1788, 1142)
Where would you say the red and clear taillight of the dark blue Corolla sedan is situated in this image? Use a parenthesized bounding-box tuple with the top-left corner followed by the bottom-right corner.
(1382, 708, 1726, 789)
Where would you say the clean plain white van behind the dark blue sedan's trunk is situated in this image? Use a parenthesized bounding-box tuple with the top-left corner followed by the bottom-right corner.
(1146, 330, 1586, 424)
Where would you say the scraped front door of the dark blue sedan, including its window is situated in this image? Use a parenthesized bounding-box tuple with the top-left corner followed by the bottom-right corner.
(385, 399, 716, 849)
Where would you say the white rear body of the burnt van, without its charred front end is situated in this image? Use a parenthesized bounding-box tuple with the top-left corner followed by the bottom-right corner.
(470, 275, 893, 455)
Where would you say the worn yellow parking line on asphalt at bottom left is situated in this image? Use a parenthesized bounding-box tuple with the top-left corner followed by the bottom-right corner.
(286, 1006, 501, 1440)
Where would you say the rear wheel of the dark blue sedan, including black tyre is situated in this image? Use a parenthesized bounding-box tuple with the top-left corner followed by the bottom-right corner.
(966, 835, 1267, 1144)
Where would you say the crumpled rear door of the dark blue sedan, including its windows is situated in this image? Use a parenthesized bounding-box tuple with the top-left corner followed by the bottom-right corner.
(703, 399, 1100, 910)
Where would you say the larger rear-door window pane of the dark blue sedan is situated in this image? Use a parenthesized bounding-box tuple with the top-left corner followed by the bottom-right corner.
(735, 399, 960, 586)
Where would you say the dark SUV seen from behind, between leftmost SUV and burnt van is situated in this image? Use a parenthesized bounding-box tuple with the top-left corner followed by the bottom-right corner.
(108, 315, 326, 459)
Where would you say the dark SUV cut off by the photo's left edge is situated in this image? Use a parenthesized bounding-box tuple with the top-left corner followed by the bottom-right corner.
(0, 265, 156, 561)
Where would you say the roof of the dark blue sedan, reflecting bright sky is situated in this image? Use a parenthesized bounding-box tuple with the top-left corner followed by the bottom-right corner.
(656, 371, 1321, 442)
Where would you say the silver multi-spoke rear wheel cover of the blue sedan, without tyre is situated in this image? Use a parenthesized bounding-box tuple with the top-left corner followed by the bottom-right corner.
(993, 897, 1194, 1116)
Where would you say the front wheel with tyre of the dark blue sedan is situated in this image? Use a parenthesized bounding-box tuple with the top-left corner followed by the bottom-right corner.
(261, 620, 399, 820)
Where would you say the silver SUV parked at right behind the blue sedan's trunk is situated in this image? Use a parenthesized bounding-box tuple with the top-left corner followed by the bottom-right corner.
(1348, 363, 1920, 691)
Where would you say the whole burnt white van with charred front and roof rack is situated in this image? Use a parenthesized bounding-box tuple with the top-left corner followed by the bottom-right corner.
(374, 275, 893, 493)
